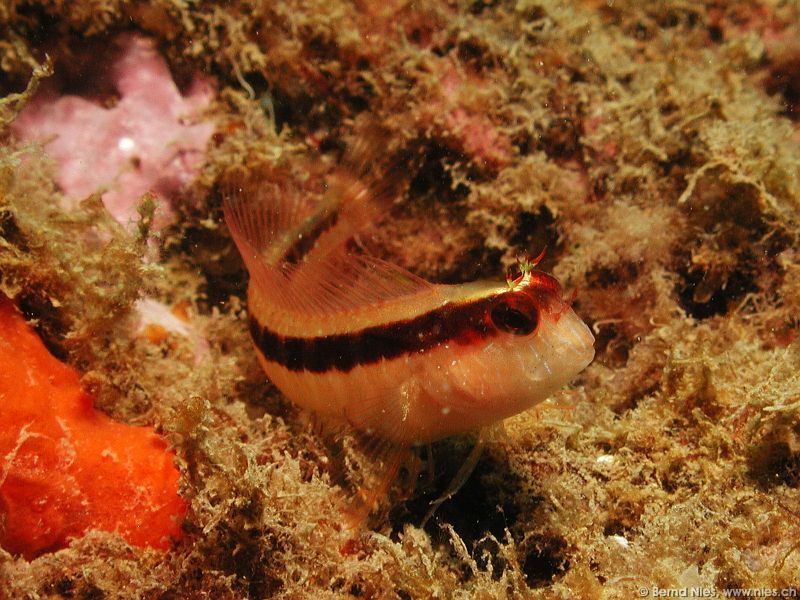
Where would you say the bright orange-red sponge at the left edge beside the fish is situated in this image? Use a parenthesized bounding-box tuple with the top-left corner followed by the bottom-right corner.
(0, 295, 186, 559)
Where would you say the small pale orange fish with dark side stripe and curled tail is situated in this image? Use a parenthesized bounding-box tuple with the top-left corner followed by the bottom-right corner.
(223, 148, 594, 512)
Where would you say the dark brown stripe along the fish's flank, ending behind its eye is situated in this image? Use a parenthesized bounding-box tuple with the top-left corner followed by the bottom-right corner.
(250, 298, 497, 373)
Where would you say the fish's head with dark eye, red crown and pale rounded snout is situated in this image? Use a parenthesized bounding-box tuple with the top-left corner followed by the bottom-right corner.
(423, 271, 594, 435)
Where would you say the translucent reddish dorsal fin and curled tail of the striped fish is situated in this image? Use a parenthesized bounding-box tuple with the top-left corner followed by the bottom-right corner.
(224, 144, 434, 324)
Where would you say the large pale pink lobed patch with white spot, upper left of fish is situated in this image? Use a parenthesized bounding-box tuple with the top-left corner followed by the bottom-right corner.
(13, 34, 214, 227)
